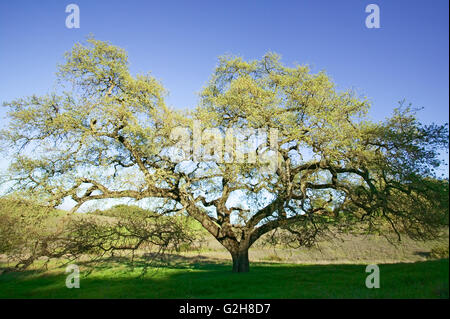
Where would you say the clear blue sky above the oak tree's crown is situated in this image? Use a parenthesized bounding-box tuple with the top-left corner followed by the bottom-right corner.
(0, 0, 449, 172)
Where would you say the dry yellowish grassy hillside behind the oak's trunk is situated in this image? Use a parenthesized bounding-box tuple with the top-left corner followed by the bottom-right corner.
(86, 205, 449, 264)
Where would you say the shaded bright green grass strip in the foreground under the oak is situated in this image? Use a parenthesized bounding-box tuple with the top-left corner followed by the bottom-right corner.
(0, 259, 449, 298)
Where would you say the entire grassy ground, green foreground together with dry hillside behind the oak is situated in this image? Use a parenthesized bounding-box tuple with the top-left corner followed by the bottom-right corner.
(0, 203, 449, 298)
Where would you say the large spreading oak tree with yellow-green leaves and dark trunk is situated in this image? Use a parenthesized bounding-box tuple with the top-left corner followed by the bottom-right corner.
(2, 39, 448, 272)
